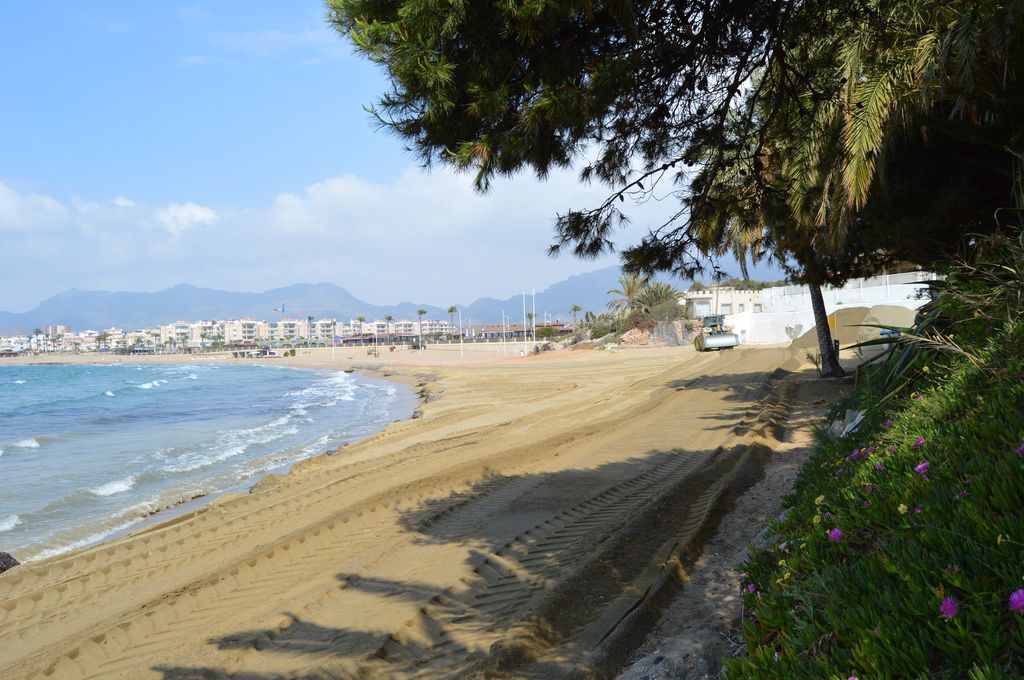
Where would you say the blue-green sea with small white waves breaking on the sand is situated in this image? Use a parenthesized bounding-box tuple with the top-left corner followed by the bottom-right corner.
(0, 364, 415, 561)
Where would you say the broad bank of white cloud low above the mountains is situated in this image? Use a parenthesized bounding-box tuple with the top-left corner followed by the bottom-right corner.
(0, 168, 770, 310)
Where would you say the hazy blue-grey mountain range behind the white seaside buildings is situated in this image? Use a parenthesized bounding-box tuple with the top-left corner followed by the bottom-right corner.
(0, 266, 638, 335)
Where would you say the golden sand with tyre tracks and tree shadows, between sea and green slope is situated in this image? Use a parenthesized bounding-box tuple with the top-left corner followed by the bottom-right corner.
(0, 348, 786, 680)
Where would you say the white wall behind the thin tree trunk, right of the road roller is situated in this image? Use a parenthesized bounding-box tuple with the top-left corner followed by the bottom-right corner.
(725, 271, 937, 345)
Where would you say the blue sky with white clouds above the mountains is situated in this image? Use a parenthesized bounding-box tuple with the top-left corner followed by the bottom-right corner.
(0, 0, 773, 311)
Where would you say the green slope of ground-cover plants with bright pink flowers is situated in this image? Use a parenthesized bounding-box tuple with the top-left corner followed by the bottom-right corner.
(727, 232, 1024, 678)
